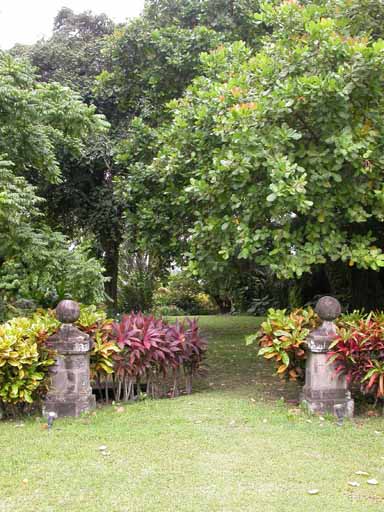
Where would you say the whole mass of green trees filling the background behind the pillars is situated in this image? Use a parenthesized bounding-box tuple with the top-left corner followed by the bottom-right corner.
(0, 0, 384, 316)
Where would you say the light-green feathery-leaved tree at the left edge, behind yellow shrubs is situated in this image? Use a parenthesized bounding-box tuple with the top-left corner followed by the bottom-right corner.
(0, 53, 107, 310)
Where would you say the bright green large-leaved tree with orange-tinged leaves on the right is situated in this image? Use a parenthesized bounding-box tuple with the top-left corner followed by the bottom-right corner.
(139, 2, 384, 288)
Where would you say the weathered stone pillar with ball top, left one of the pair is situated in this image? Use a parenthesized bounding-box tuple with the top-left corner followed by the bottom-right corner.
(43, 300, 96, 417)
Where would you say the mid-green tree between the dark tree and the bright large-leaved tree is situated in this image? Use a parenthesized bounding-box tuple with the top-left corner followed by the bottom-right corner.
(100, 0, 265, 308)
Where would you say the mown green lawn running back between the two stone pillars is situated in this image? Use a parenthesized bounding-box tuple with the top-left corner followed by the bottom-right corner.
(0, 317, 384, 512)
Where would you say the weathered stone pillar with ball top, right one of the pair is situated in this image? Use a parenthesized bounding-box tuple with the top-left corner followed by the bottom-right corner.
(302, 297, 354, 418)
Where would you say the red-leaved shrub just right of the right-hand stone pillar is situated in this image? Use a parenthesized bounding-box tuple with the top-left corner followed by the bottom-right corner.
(329, 313, 384, 399)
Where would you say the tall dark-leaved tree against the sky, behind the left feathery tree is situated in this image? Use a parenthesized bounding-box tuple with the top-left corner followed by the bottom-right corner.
(12, 8, 122, 304)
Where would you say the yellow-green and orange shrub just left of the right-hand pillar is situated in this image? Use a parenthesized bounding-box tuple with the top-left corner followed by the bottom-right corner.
(247, 308, 319, 380)
